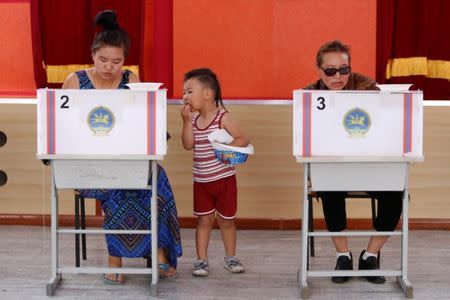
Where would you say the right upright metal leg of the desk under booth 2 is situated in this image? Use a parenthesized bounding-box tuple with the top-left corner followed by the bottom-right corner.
(150, 160, 159, 297)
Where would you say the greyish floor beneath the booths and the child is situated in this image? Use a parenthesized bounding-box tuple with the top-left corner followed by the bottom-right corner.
(0, 226, 450, 300)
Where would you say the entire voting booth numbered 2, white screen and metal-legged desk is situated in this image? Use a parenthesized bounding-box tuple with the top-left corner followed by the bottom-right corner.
(37, 88, 167, 295)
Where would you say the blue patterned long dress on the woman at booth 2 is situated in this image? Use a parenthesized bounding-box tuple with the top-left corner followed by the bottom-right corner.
(76, 70, 182, 267)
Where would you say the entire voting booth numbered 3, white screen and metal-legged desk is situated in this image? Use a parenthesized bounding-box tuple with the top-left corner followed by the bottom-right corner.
(293, 89, 424, 298)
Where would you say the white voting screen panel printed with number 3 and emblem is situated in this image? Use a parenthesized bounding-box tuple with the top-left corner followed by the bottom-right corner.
(293, 90, 423, 158)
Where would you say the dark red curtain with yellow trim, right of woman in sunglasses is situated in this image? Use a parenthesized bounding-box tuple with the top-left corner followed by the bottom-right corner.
(376, 0, 450, 100)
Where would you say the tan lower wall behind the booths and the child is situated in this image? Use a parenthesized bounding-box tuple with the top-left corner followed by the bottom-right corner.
(0, 104, 450, 219)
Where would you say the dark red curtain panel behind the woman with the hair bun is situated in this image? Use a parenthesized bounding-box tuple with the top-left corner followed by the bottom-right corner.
(39, 0, 144, 86)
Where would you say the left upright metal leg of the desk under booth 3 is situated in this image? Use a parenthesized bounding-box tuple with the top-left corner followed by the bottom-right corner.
(297, 164, 310, 299)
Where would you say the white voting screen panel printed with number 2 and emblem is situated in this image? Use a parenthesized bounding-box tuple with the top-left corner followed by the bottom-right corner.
(37, 89, 167, 158)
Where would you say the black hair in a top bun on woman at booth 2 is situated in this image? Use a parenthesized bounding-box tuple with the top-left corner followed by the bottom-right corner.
(91, 10, 130, 57)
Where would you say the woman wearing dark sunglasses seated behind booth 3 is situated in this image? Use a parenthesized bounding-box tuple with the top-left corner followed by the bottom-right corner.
(305, 41, 402, 283)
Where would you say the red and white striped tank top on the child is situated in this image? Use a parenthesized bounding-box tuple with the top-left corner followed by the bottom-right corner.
(192, 109, 235, 182)
